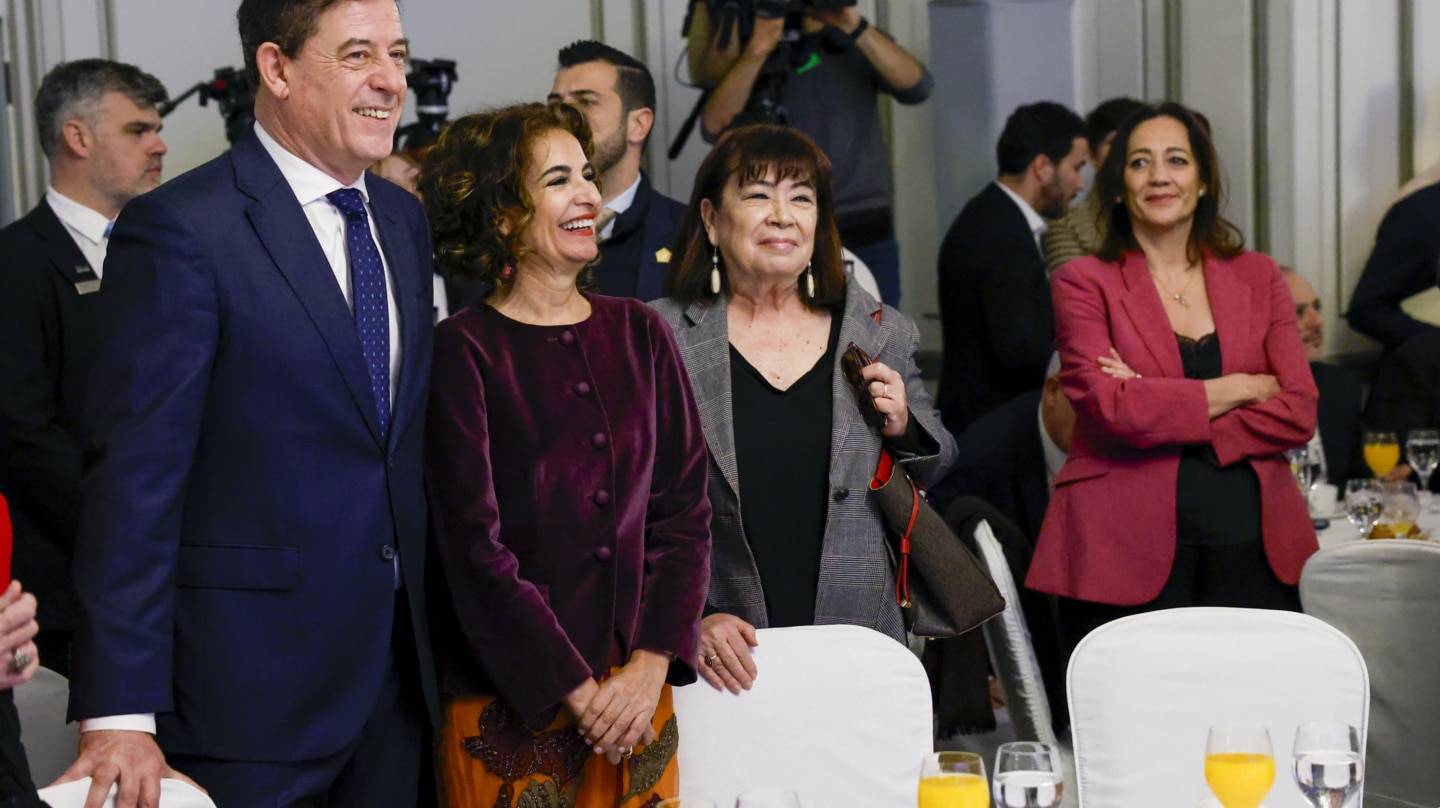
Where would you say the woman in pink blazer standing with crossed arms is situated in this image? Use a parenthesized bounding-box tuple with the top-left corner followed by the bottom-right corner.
(1025, 102, 1318, 647)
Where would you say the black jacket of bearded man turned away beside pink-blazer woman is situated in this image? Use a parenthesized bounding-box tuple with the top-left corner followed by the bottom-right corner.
(937, 183, 1056, 435)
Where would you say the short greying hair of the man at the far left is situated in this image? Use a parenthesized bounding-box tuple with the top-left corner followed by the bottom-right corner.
(35, 59, 168, 157)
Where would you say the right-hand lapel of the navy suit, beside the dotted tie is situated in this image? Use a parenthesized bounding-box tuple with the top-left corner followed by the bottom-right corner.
(367, 185, 433, 441)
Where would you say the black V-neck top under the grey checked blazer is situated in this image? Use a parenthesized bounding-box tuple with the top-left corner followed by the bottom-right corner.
(730, 314, 841, 628)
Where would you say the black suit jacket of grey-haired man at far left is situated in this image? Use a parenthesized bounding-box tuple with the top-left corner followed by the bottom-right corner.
(0, 202, 99, 631)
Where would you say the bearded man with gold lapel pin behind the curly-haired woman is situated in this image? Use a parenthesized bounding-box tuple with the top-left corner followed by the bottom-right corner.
(550, 40, 685, 301)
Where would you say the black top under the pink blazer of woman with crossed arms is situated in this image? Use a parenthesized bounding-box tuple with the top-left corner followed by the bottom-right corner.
(1175, 331, 1263, 546)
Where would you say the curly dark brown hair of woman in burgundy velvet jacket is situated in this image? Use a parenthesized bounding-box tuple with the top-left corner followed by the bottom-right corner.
(416, 104, 595, 288)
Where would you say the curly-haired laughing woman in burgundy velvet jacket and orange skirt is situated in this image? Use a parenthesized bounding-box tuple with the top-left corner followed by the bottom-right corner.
(420, 104, 710, 808)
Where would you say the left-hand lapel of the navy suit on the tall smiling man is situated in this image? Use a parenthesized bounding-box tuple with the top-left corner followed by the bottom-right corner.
(230, 134, 382, 442)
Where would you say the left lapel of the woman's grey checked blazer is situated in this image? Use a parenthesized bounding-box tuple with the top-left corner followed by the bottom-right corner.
(675, 295, 740, 503)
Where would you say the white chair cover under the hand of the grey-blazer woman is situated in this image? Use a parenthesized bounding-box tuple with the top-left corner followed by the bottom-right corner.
(674, 625, 933, 808)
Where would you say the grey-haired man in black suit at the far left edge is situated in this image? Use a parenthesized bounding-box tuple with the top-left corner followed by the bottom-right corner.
(0, 59, 166, 675)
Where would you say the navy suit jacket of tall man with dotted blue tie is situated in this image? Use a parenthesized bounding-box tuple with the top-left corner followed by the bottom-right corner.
(69, 133, 436, 760)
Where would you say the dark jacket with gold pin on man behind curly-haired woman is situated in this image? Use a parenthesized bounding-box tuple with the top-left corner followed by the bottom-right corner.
(595, 171, 685, 301)
